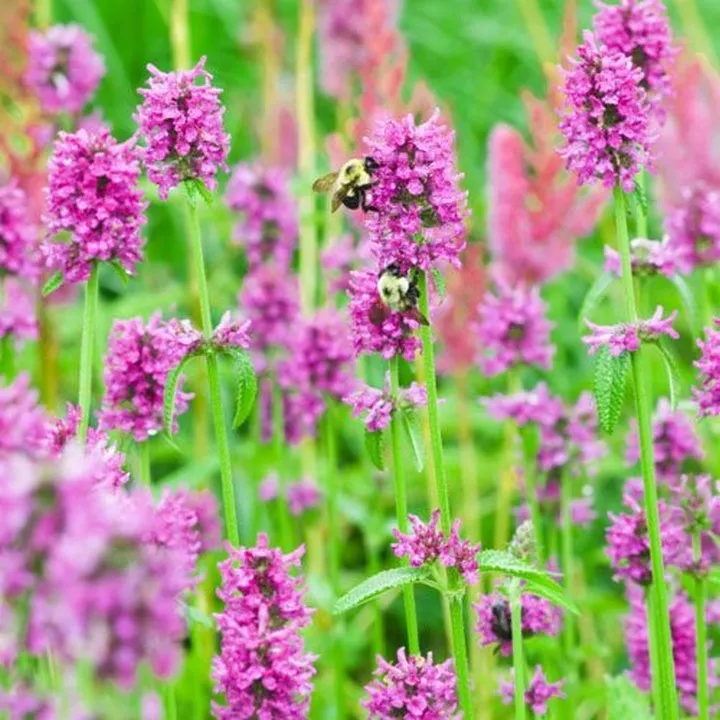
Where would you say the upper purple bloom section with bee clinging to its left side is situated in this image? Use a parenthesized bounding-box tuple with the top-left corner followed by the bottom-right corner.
(365, 111, 468, 272)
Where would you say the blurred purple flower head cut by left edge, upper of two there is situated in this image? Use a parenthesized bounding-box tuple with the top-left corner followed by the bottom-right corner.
(0, 180, 39, 280)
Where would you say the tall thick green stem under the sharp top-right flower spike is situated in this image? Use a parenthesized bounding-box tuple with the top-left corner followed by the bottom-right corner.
(615, 186, 678, 720)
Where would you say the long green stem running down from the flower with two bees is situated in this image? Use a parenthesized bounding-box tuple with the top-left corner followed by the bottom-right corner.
(418, 272, 473, 718)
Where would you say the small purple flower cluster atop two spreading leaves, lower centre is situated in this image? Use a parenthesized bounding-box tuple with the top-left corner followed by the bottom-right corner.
(392, 510, 480, 585)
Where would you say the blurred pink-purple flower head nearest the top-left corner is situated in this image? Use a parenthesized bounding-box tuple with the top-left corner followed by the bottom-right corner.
(25, 25, 105, 115)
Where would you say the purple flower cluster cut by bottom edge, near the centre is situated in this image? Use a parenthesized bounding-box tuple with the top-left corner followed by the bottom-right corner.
(363, 648, 459, 720)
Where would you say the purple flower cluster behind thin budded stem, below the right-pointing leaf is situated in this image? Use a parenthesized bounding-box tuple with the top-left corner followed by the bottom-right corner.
(473, 592, 562, 656)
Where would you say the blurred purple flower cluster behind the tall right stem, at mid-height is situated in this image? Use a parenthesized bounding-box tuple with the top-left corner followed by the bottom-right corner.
(626, 398, 704, 483)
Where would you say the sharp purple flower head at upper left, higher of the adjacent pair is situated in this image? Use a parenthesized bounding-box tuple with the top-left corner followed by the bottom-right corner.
(135, 57, 230, 199)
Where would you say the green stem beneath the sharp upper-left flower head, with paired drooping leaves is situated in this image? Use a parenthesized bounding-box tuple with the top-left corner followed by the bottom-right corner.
(188, 200, 240, 546)
